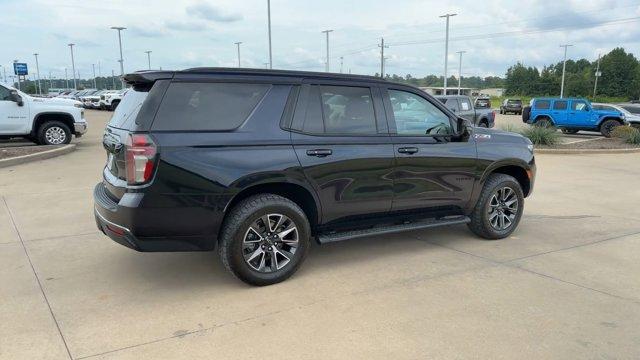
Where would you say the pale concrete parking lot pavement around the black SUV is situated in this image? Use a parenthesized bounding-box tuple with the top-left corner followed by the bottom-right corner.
(0, 111, 640, 359)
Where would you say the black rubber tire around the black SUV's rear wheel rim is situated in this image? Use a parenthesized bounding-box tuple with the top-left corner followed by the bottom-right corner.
(219, 194, 311, 286)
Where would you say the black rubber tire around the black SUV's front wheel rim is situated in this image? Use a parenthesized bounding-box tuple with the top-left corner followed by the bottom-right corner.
(467, 174, 524, 240)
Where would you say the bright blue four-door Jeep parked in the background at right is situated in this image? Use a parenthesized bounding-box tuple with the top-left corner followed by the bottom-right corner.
(522, 98, 626, 137)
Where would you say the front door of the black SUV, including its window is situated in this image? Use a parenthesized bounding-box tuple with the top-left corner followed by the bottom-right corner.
(383, 87, 477, 211)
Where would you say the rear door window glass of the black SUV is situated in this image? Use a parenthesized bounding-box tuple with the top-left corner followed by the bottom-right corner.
(318, 86, 378, 134)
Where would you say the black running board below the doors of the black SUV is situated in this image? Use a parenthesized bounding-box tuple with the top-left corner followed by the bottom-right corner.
(318, 216, 471, 244)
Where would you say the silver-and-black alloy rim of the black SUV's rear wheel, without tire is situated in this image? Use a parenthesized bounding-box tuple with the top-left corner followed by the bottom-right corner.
(242, 214, 299, 273)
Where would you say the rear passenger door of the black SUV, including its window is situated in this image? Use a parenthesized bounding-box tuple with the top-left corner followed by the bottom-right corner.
(291, 82, 394, 223)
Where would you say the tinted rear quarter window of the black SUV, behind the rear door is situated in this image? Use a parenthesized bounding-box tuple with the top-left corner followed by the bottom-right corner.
(153, 83, 270, 131)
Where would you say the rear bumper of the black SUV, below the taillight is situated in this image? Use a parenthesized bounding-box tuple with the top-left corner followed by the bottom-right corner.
(93, 182, 217, 252)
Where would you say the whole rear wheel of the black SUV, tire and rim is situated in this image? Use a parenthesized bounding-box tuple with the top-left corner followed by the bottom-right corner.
(219, 194, 311, 286)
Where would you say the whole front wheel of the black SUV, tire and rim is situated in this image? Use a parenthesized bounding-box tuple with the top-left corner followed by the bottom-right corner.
(468, 174, 524, 240)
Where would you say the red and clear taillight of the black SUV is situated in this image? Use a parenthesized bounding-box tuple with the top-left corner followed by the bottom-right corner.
(125, 134, 157, 185)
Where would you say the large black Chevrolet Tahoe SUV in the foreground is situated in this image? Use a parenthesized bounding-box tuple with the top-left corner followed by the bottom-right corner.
(94, 68, 535, 285)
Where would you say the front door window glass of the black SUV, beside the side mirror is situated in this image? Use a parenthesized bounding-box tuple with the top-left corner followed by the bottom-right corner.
(389, 90, 455, 135)
